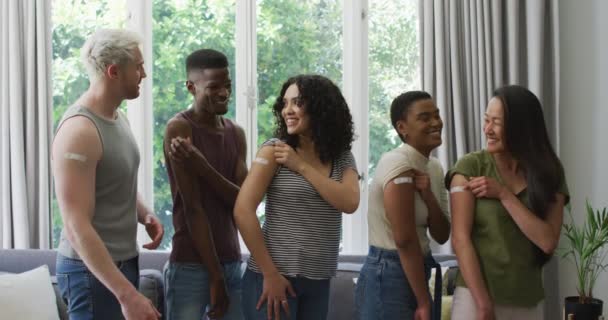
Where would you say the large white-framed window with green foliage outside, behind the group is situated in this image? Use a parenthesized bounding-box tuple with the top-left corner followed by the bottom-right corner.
(52, 0, 420, 254)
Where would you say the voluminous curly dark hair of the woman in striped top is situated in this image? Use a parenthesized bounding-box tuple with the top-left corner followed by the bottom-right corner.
(272, 75, 354, 163)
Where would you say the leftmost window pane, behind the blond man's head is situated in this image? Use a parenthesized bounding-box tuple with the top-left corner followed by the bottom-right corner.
(51, 0, 126, 248)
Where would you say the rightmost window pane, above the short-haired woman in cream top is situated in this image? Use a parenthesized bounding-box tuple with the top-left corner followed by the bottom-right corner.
(369, 0, 420, 181)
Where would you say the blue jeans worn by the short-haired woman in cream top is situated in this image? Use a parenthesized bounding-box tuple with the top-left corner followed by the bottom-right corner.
(355, 246, 436, 320)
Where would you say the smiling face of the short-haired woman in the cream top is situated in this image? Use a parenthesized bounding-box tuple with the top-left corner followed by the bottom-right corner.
(397, 99, 443, 153)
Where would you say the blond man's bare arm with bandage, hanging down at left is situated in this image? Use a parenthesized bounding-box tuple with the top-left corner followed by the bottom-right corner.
(52, 117, 158, 319)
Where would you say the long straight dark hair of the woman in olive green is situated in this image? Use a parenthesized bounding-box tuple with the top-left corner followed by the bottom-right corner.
(494, 85, 563, 218)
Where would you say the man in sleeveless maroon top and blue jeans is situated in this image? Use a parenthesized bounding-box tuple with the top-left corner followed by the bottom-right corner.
(164, 49, 247, 320)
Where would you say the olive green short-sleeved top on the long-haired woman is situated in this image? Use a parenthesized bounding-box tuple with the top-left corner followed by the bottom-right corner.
(446, 150, 569, 307)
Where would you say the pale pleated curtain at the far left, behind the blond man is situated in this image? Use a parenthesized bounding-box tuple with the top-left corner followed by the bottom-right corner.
(0, 0, 52, 248)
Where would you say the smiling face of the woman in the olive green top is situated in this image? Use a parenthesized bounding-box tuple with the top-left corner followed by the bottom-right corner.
(483, 97, 507, 153)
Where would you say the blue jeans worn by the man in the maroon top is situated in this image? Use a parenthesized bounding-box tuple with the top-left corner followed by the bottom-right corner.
(164, 261, 243, 320)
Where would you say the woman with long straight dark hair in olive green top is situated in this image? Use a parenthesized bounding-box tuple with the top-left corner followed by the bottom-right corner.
(446, 86, 568, 320)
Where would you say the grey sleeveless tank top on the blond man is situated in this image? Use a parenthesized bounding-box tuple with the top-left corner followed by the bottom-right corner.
(57, 105, 139, 261)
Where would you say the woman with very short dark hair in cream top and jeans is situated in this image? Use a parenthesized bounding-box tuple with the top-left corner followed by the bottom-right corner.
(355, 91, 450, 320)
